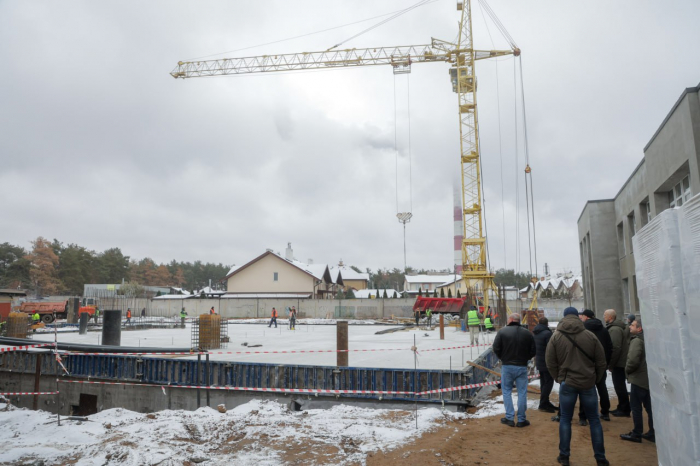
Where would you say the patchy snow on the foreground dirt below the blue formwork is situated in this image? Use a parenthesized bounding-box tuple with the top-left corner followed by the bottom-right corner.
(0, 400, 466, 466)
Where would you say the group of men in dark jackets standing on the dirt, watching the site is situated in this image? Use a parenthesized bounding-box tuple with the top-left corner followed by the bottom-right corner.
(493, 307, 655, 465)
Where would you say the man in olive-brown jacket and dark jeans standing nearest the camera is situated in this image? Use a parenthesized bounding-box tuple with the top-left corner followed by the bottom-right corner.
(545, 307, 610, 465)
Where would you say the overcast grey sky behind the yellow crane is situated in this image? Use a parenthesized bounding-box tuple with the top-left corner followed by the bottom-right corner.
(0, 0, 700, 271)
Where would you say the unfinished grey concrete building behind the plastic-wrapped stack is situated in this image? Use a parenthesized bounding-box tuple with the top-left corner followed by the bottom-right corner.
(578, 85, 700, 317)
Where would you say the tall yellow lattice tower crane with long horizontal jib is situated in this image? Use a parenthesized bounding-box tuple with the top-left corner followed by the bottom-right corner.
(170, 0, 520, 314)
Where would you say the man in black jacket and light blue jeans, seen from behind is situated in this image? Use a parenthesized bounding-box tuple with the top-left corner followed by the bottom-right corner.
(493, 314, 537, 427)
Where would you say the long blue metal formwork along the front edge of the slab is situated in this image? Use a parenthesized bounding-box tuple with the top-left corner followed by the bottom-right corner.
(0, 350, 504, 402)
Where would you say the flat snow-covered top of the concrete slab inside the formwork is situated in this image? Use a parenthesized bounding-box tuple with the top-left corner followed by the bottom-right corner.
(27, 321, 495, 370)
